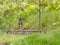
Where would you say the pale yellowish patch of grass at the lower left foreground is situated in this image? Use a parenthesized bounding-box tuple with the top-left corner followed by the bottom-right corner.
(0, 33, 25, 45)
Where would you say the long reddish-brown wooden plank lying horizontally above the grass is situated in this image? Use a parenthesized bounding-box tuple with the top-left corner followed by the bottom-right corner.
(4, 30, 41, 34)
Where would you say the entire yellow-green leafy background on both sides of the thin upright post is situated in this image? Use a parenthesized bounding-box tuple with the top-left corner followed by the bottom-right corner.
(0, 0, 60, 30)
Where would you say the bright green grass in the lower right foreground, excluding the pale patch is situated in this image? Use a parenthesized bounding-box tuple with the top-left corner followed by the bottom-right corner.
(22, 31, 60, 45)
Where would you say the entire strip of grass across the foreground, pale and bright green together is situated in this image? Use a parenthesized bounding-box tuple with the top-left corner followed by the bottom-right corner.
(0, 30, 60, 45)
